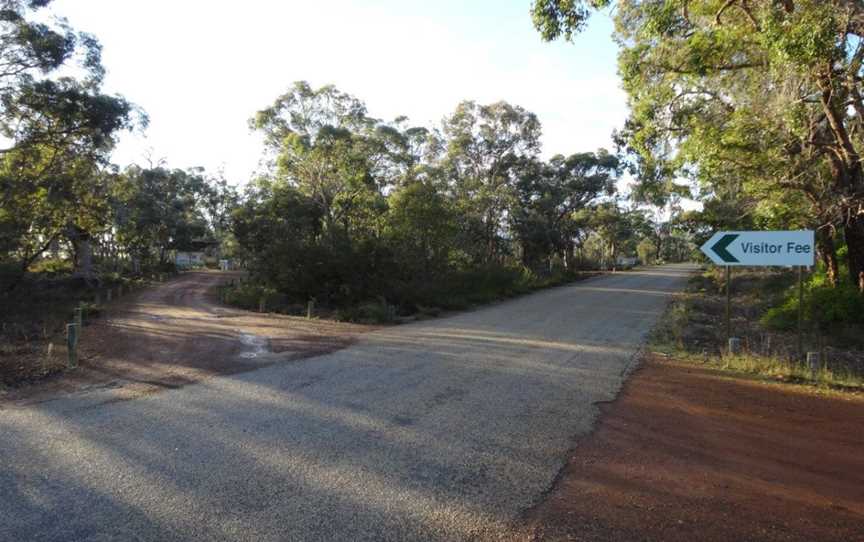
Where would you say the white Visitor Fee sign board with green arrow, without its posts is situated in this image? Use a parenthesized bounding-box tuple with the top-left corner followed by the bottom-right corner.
(701, 230, 816, 266)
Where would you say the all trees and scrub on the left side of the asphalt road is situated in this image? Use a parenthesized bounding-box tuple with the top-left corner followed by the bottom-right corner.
(0, 0, 694, 388)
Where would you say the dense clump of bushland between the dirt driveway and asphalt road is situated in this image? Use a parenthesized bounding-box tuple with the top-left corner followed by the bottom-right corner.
(227, 82, 690, 315)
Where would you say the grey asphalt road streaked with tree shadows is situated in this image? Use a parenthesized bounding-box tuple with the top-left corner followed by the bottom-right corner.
(0, 266, 692, 541)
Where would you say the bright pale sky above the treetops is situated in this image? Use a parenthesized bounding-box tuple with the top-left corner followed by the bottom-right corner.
(51, 0, 627, 184)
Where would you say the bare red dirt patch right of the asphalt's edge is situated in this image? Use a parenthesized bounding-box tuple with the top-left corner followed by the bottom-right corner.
(523, 358, 864, 542)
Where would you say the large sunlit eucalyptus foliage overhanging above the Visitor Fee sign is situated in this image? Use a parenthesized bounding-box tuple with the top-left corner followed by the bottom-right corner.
(532, 0, 864, 291)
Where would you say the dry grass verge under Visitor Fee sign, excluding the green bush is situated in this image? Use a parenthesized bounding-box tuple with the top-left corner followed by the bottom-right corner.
(652, 270, 864, 391)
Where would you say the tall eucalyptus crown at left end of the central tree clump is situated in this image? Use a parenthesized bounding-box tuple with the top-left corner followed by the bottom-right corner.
(251, 82, 407, 247)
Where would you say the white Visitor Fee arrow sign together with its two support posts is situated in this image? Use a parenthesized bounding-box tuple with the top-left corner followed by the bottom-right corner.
(700, 230, 816, 359)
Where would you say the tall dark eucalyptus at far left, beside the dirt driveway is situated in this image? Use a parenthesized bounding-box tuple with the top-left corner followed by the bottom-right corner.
(0, 0, 138, 284)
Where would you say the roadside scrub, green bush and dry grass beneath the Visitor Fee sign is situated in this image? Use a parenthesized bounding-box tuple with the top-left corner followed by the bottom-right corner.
(651, 268, 864, 392)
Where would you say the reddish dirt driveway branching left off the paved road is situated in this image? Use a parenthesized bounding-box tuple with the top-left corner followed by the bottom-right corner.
(0, 271, 371, 406)
